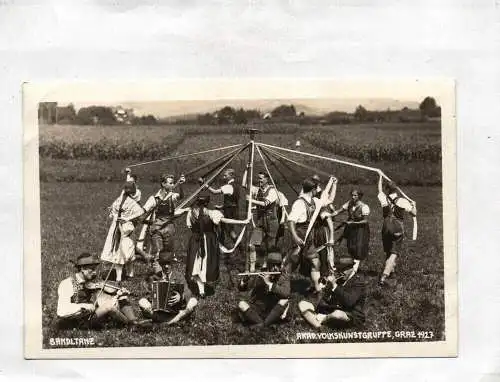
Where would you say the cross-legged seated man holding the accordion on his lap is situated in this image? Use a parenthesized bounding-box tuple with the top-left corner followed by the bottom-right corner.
(139, 261, 198, 325)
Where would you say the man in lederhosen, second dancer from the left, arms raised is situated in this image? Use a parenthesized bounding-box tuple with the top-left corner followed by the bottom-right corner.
(143, 174, 186, 272)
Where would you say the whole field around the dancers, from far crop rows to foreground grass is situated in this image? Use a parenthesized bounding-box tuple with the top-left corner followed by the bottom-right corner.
(40, 124, 445, 346)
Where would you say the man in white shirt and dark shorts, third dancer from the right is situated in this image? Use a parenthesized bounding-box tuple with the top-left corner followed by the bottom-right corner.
(287, 179, 333, 291)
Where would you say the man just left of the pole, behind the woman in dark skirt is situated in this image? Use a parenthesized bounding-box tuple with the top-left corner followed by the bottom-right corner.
(199, 168, 240, 244)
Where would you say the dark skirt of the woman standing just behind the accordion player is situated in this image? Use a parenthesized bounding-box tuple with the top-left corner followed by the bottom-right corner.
(186, 232, 220, 282)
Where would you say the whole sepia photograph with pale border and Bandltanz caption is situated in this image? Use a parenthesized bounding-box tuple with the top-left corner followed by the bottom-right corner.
(23, 80, 457, 358)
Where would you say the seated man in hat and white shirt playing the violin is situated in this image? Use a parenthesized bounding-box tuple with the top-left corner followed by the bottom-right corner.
(57, 253, 150, 327)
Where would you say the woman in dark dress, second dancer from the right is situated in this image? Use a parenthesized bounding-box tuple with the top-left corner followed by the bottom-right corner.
(333, 189, 370, 270)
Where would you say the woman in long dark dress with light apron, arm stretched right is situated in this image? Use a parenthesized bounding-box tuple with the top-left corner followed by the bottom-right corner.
(186, 194, 250, 298)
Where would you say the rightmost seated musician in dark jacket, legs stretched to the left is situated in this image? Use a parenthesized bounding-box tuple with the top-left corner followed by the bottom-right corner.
(299, 257, 366, 328)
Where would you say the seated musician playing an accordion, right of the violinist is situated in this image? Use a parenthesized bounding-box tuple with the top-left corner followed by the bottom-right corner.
(139, 259, 198, 325)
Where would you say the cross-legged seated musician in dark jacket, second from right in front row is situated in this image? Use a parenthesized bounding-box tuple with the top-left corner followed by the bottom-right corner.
(238, 249, 290, 326)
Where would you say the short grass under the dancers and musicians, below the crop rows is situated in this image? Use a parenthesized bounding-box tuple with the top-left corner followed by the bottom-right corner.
(41, 183, 444, 346)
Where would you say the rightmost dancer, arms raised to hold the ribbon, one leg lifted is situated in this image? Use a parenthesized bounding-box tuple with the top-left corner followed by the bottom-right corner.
(378, 175, 417, 285)
